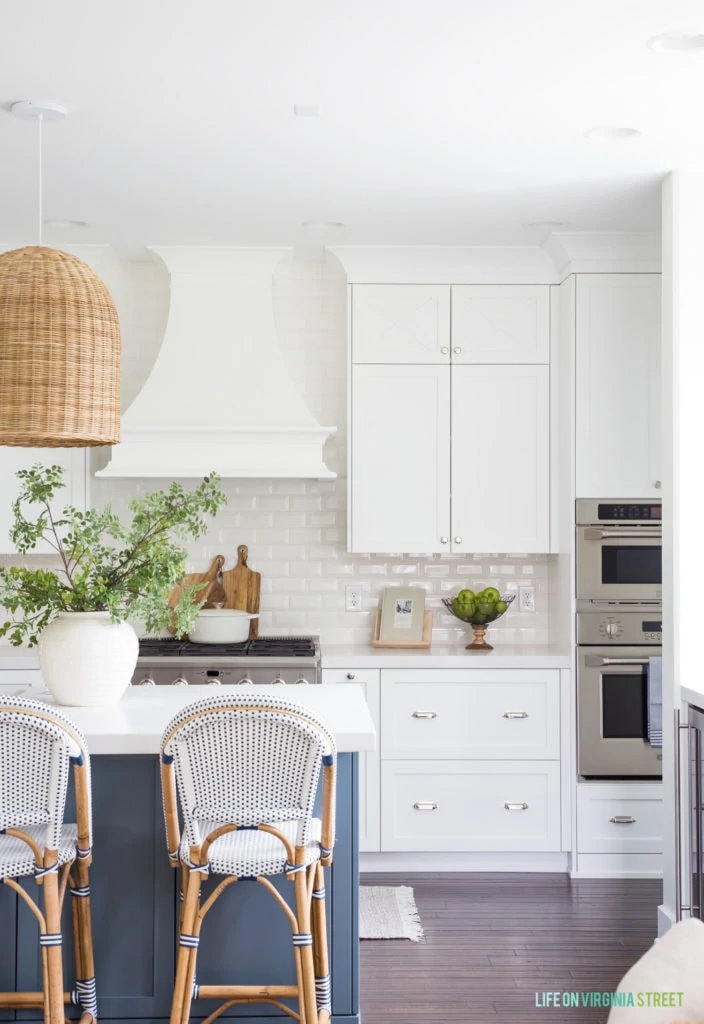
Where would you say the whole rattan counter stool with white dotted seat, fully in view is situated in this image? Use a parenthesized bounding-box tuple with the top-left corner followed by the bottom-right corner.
(162, 691, 336, 1024)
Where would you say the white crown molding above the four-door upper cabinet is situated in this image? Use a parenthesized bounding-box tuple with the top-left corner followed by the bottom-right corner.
(328, 246, 556, 285)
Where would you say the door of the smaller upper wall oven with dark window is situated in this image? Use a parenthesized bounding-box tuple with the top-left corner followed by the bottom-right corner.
(577, 526, 662, 601)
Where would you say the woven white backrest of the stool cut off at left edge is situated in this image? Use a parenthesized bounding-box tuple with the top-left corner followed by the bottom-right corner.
(0, 696, 90, 850)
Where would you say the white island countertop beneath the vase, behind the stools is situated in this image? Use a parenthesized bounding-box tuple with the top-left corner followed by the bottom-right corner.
(0, 685, 377, 755)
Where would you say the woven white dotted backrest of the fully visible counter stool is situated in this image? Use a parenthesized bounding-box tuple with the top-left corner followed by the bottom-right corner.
(162, 692, 335, 846)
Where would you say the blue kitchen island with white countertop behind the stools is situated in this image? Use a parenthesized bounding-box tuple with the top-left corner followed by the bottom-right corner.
(0, 685, 375, 1024)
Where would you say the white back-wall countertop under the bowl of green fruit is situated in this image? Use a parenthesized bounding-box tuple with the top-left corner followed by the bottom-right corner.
(321, 644, 572, 669)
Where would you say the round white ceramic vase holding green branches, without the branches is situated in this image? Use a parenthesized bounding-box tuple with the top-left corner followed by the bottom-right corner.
(39, 611, 139, 707)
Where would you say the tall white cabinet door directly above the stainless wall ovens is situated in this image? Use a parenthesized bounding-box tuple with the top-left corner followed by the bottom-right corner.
(576, 273, 662, 499)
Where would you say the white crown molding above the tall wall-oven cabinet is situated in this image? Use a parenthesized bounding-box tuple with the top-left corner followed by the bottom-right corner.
(542, 231, 661, 282)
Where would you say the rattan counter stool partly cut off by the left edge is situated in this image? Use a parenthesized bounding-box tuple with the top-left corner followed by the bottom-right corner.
(0, 696, 97, 1024)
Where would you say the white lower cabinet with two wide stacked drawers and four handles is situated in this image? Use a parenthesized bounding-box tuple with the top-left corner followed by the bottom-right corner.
(380, 669, 562, 853)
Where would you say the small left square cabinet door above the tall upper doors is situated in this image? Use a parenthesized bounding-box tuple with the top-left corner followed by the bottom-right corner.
(352, 285, 450, 364)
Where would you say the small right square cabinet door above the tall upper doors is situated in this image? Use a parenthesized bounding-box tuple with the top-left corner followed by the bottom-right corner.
(451, 285, 551, 364)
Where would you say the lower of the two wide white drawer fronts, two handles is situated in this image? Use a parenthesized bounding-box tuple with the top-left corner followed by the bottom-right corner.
(382, 761, 560, 852)
